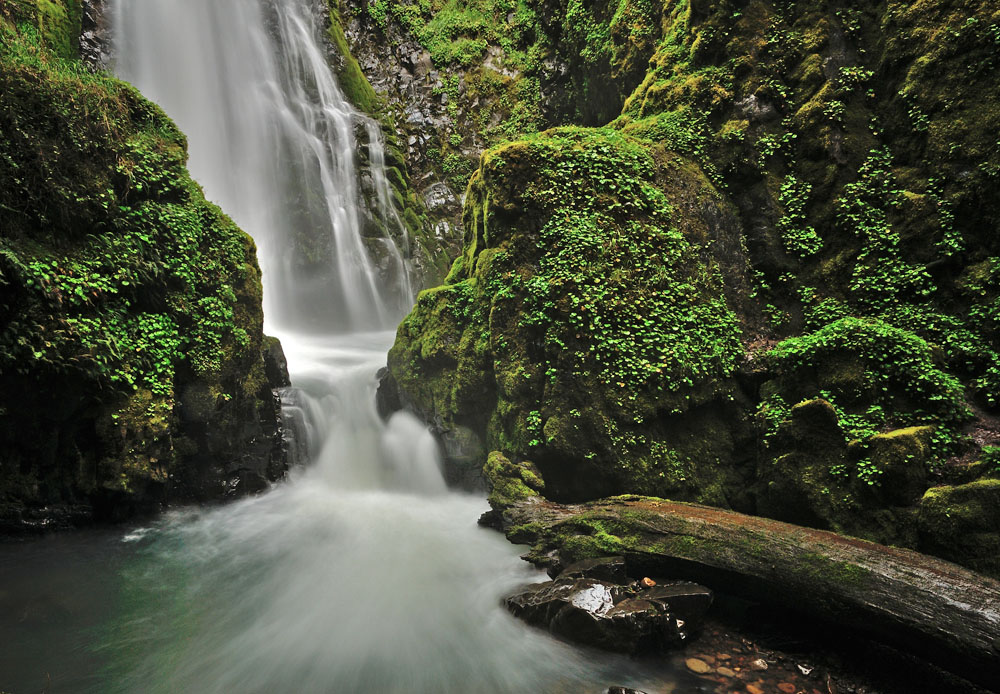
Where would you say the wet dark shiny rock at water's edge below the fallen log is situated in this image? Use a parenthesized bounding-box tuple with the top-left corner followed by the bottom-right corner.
(505, 557, 712, 653)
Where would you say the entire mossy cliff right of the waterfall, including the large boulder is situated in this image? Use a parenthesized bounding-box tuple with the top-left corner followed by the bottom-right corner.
(374, 0, 1000, 572)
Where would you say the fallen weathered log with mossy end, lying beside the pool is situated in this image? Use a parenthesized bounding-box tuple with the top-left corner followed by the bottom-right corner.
(493, 497, 1000, 691)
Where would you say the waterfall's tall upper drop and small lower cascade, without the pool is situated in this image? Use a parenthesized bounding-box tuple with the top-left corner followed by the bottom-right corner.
(112, 0, 428, 491)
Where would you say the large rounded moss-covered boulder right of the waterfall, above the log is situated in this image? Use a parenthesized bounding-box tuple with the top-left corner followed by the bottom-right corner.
(389, 129, 742, 504)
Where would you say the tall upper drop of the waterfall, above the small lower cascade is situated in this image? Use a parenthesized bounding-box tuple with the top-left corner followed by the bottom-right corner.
(113, 0, 412, 334)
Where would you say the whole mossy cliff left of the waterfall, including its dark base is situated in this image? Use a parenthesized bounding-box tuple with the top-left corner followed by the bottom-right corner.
(0, 1, 284, 527)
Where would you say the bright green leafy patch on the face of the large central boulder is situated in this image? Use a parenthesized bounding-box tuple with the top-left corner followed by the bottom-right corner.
(508, 131, 740, 406)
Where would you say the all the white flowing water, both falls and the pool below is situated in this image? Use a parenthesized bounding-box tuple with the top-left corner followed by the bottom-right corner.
(0, 0, 694, 694)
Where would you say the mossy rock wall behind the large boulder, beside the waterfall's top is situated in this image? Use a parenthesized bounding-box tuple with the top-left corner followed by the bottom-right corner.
(348, 0, 661, 190)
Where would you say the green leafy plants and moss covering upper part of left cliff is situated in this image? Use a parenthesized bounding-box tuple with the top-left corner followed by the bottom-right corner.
(0, 22, 260, 402)
